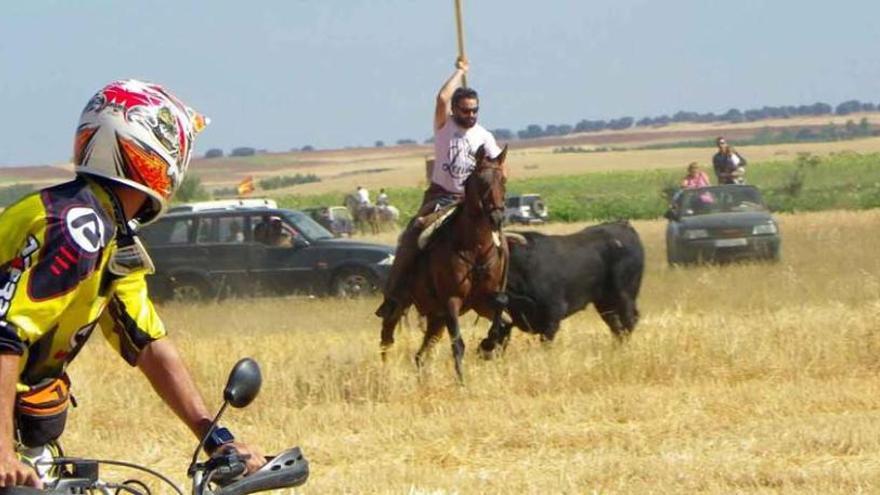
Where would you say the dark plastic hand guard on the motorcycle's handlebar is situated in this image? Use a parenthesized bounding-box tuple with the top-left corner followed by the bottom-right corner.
(215, 447, 309, 495)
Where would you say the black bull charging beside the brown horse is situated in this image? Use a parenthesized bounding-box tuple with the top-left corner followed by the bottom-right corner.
(480, 221, 645, 352)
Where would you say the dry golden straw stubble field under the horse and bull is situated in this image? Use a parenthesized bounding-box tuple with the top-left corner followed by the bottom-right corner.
(66, 211, 880, 494)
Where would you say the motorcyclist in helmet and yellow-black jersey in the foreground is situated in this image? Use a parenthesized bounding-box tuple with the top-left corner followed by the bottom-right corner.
(0, 80, 265, 487)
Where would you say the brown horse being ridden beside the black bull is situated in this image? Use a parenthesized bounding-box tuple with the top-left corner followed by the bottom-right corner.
(382, 147, 508, 381)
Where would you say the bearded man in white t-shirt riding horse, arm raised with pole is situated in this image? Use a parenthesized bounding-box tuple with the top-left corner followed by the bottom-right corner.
(376, 58, 501, 318)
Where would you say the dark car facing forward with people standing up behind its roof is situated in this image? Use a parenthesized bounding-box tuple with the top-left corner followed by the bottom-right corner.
(666, 184, 780, 265)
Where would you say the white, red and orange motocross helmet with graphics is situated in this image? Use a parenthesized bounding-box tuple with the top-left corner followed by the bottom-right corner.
(73, 79, 207, 225)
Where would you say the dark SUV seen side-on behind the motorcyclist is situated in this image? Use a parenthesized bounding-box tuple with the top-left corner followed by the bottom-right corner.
(141, 206, 394, 300)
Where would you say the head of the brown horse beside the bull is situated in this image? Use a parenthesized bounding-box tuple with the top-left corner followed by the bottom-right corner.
(465, 142, 507, 230)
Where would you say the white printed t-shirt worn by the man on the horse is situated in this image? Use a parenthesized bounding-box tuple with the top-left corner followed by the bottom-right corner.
(431, 116, 501, 194)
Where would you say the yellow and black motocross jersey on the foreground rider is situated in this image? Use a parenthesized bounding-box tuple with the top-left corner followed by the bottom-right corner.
(0, 178, 165, 390)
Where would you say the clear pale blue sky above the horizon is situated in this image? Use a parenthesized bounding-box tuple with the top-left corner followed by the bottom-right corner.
(0, 0, 880, 165)
